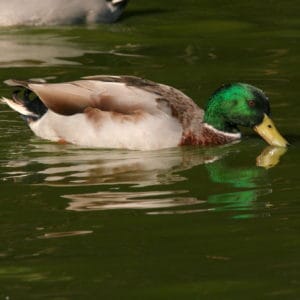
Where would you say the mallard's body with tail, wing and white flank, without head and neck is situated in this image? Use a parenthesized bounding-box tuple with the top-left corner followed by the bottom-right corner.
(4, 76, 203, 150)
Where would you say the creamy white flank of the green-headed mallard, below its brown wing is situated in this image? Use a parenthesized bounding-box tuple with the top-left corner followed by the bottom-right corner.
(30, 111, 182, 150)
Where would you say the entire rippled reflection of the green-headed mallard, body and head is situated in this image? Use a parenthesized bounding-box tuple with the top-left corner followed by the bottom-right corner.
(2, 143, 283, 216)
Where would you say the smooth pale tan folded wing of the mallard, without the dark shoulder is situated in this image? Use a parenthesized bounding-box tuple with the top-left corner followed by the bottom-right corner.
(28, 80, 157, 115)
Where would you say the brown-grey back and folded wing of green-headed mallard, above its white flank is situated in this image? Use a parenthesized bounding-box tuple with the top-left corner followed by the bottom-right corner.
(6, 75, 203, 128)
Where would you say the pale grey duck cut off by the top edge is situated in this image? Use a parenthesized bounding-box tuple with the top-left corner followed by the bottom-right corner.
(0, 0, 129, 26)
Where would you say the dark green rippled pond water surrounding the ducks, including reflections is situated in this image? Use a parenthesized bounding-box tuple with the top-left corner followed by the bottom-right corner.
(0, 0, 300, 300)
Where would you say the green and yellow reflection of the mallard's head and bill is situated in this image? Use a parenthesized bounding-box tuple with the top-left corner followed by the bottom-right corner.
(206, 146, 286, 218)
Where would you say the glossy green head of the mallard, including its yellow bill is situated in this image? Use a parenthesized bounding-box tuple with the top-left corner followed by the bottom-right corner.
(204, 83, 288, 147)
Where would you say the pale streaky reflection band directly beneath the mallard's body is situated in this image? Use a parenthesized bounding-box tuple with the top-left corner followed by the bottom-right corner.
(6, 143, 225, 188)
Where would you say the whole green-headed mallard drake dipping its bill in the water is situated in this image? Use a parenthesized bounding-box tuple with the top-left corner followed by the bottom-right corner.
(1, 75, 288, 150)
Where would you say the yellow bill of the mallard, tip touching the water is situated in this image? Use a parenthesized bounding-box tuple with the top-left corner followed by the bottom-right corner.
(253, 114, 289, 147)
